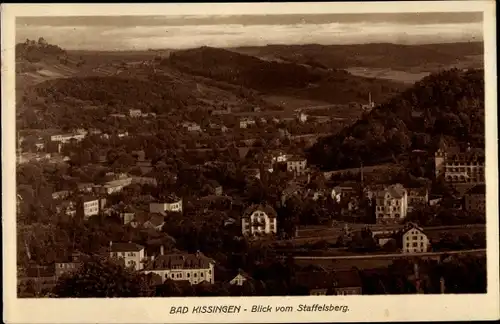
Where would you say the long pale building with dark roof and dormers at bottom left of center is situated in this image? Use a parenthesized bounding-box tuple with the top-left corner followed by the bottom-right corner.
(144, 252, 215, 285)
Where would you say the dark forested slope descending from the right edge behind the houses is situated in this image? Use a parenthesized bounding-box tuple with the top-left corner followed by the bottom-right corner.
(309, 69, 484, 170)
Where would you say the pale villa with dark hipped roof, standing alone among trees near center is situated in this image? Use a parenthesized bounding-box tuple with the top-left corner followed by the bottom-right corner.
(241, 205, 277, 237)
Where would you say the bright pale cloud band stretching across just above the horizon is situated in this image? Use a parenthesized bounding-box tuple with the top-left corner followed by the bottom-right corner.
(16, 22, 483, 50)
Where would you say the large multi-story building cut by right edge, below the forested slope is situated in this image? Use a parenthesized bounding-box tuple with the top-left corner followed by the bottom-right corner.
(434, 142, 485, 185)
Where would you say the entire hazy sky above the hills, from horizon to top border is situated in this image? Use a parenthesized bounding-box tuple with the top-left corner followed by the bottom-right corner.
(16, 13, 483, 50)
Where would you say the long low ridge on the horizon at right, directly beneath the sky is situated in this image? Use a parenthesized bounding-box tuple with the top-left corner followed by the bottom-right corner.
(230, 42, 484, 72)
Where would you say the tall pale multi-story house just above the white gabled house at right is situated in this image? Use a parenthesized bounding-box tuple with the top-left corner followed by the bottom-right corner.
(375, 184, 408, 224)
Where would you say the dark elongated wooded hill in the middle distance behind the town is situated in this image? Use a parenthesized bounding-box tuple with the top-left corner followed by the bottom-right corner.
(161, 47, 405, 103)
